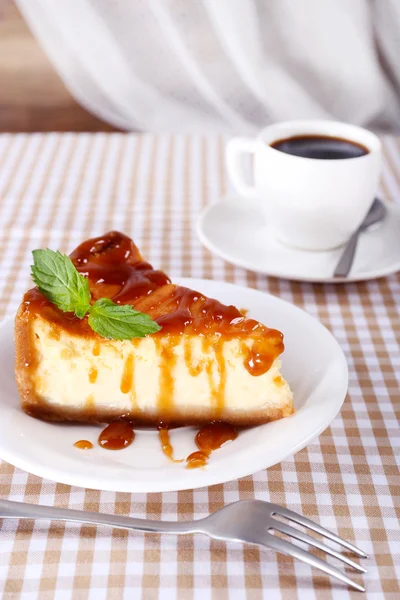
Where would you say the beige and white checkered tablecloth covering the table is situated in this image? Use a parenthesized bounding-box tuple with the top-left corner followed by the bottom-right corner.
(0, 133, 400, 600)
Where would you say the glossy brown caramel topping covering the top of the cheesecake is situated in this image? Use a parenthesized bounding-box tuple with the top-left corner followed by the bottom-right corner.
(24, 231, 283, 355)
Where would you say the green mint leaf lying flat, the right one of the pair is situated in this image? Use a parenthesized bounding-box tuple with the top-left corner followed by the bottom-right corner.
(89, 298, 161, 340)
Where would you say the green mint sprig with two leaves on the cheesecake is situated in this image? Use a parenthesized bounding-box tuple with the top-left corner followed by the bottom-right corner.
(32, 248, 161, 340)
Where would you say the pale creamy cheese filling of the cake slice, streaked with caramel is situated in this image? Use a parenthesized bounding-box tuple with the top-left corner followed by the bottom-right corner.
(32, 317, 292, 416)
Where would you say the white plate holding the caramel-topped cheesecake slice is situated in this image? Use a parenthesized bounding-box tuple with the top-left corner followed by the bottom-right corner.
(0, 279, 348, 492)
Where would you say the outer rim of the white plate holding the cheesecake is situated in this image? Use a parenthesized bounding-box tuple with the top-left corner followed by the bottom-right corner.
(0, 277, 349, 493)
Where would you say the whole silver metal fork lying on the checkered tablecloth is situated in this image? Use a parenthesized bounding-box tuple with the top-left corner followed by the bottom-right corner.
(0, 500, 367, 592)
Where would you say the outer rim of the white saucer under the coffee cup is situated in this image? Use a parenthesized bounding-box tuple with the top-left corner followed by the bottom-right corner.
(195, 193, 400, 284)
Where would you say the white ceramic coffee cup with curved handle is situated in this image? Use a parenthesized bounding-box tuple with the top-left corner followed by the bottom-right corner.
(226, 120, 381, 250)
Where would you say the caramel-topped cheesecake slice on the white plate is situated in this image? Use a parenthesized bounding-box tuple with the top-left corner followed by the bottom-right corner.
(15, 232, 294, 426)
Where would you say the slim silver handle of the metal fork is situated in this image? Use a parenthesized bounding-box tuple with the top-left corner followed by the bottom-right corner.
(0, 500, 199, 535)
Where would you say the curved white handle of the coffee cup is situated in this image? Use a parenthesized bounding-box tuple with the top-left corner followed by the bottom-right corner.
(225, 137, 257, 199)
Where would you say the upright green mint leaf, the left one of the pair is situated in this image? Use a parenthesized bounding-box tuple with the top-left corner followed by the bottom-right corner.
(32, 249, 90, 319)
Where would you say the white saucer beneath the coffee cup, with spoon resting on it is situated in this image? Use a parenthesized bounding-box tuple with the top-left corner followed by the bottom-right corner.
(197, 196, 400, 283)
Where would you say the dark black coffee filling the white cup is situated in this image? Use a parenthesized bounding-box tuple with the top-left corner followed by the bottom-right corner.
(271, 135, 369, 160)
